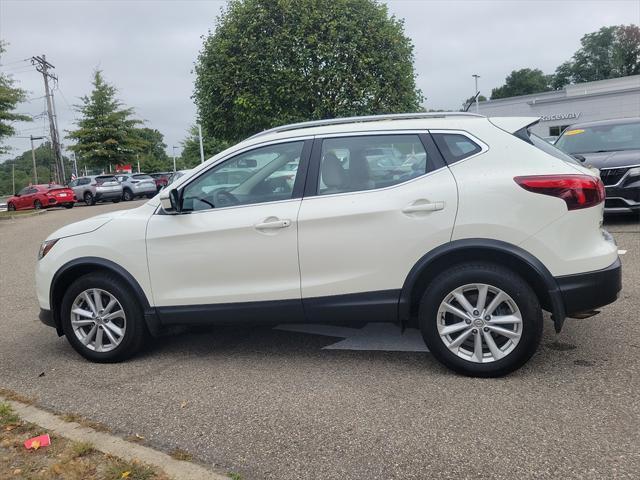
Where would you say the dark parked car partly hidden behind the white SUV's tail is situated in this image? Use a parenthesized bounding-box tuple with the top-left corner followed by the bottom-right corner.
(555, 118, 640, 213)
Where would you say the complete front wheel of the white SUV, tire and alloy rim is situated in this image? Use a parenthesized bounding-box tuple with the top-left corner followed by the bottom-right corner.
(60, 272, 149, 363)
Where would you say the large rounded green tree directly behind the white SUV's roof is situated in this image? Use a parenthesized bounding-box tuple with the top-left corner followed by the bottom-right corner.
(194, 0, 423, 142)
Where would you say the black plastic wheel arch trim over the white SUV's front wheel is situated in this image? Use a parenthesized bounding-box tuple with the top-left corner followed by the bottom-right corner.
(49, 257, 160, 336)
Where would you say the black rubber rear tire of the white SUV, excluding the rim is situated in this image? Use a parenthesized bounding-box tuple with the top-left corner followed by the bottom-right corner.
(420, 263, 542, 377)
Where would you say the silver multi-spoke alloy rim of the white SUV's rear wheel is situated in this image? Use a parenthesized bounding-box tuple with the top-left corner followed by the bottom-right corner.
(437, 283, 522, 363)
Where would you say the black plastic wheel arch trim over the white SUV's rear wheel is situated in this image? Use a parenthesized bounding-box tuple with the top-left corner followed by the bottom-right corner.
(398, 238, 566, 332)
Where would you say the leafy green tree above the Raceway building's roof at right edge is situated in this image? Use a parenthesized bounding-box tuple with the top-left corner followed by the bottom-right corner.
(553, 25, 640, 88)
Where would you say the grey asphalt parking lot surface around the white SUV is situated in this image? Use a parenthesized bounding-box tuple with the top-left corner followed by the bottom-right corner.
(0, 202, 640, 479)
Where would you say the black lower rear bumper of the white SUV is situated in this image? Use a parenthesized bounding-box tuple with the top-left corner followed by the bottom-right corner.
(556, 258, 622, 316)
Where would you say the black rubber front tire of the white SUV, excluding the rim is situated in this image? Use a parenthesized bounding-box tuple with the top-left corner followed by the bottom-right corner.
(60, 273, 147, 363)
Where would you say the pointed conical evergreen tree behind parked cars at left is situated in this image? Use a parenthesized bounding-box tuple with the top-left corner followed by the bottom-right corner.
(68, 70, 145, 168)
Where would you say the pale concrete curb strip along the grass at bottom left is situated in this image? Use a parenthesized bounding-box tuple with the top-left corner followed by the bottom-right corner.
(0, 396, 229, 480)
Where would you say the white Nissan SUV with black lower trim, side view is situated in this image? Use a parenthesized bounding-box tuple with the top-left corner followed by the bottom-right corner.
(36, 113, 621, 376)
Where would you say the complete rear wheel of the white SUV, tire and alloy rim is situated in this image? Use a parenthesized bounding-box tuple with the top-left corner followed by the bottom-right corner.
(419, 263, 542, 377)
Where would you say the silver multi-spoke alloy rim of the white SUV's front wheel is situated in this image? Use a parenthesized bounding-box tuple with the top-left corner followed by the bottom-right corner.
(71, 288, 127, 352)
